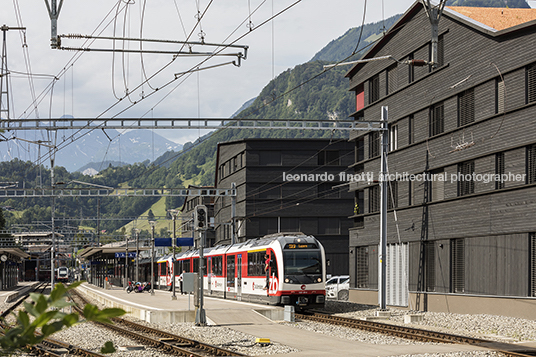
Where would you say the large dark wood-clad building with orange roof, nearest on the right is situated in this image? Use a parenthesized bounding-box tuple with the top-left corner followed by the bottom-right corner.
(347, 1, 536, 318)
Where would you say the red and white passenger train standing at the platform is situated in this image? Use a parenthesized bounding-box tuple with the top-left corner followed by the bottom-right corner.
(158, 233, 326, 310)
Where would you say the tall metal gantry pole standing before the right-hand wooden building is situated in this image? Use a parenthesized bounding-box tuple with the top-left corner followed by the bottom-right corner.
(378, 106, 389, 310)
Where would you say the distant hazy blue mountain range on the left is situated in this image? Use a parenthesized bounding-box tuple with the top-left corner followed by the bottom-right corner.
(0, 129, 182, 172)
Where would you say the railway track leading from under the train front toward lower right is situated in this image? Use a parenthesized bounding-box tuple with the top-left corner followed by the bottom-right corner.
(295, 312, 536, 357)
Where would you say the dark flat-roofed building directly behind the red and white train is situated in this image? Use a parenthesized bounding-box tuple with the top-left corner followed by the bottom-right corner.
(214, 139, 354, 274)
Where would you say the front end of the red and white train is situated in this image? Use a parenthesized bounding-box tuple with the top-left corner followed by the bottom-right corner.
(279, 235, 326, 310)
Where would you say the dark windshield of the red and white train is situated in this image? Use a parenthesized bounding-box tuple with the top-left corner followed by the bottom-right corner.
(283, 250, 322, 284)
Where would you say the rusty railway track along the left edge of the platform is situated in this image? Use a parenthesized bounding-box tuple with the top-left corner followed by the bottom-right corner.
(71, 291, 245, 357)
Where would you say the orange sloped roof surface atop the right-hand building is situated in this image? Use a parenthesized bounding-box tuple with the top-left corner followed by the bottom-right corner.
(447, 6, 536, 31)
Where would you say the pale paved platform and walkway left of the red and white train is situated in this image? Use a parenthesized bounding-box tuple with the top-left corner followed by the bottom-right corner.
(73, 283, 504, 357)
